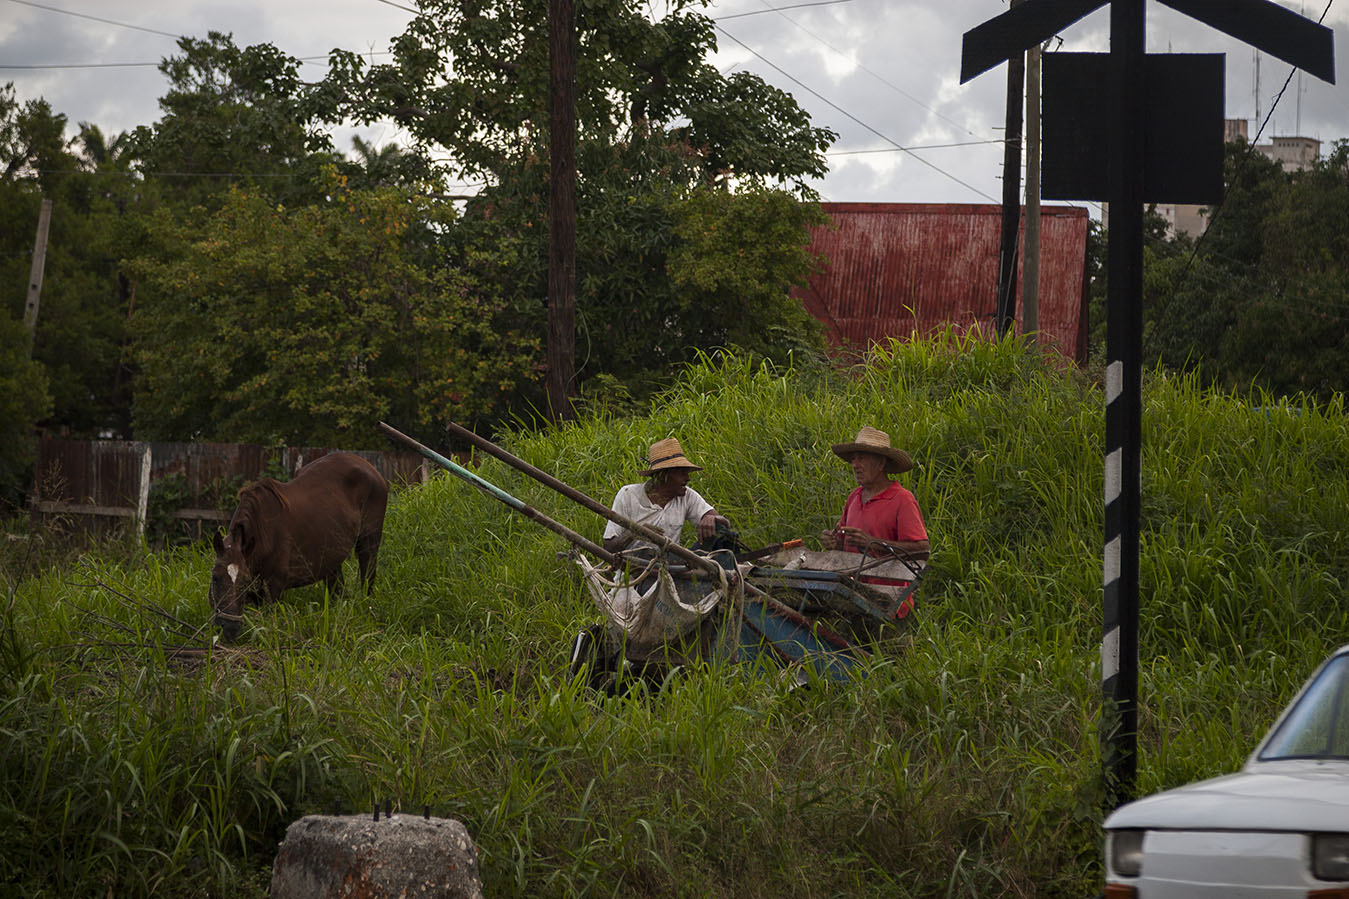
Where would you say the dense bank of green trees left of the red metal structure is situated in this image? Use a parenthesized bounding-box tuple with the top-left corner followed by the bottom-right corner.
(0, 0, 832, 469)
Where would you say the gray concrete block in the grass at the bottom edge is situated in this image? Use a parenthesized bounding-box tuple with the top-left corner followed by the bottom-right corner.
(271, 814, 483, 899)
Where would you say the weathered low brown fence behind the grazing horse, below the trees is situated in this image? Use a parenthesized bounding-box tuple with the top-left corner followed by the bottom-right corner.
(30, 437, 430, 540)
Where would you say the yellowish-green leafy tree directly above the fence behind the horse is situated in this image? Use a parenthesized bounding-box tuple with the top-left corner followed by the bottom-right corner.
(135, 168, 537, 447)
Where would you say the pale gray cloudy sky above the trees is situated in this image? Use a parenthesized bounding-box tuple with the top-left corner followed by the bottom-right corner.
(0, 0, 1349, 202)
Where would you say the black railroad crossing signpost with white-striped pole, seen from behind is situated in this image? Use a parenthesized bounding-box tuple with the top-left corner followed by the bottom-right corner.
(960, 0, 1334, 809)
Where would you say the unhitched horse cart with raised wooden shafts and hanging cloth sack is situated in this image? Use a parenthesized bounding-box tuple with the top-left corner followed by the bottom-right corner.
(379, 423, 925, 691)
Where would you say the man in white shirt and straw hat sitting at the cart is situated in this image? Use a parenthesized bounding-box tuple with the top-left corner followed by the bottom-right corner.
(604, 437, 730, 552)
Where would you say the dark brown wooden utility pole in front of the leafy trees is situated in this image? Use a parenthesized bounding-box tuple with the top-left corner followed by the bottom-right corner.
(546, 0, 576, 421)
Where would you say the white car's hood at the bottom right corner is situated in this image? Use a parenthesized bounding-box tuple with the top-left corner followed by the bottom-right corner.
(1105, 760, 1349, 833)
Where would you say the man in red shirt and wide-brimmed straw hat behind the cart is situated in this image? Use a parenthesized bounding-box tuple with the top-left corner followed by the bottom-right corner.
(820, 428, 929, 618)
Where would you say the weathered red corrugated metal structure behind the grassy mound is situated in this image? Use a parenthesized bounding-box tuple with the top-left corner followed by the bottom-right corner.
(796, 202, 1087, 362)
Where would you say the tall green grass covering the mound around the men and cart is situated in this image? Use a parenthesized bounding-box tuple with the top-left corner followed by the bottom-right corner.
(0, 335, 1349, 899)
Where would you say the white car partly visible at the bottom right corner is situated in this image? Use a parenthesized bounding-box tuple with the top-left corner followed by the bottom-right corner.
(1103, 647, 1349, 899)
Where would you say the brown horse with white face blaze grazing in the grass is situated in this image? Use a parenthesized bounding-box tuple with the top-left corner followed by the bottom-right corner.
(210, 452, 389, 640)
